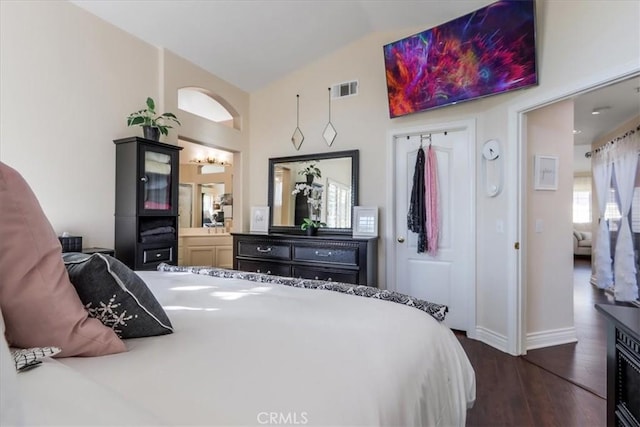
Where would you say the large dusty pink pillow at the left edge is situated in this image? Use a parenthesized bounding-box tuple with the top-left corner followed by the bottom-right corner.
(0, 162, 126, 357)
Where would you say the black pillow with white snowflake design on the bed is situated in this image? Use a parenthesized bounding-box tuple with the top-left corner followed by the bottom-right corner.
(62, 252, 173, 338)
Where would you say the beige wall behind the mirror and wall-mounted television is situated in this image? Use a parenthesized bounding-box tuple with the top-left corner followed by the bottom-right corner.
(250, 1, 640, 348)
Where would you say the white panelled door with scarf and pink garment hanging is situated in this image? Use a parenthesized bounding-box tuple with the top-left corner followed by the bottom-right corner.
(387, 121, 476, 334)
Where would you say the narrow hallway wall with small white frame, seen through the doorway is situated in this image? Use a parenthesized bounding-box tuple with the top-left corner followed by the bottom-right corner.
(523, 100, 576, 348)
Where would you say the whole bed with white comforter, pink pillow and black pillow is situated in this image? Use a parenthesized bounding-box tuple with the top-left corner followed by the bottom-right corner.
(0, 163, 475, 426)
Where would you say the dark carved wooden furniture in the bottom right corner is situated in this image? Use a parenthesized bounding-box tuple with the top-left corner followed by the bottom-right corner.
(596, 304, 640, 427)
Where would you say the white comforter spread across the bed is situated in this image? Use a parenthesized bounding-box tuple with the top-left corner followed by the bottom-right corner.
(19, 272, 475, 426)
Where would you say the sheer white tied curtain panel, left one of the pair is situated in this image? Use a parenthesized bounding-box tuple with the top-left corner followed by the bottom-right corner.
(593, 149, 613, 289)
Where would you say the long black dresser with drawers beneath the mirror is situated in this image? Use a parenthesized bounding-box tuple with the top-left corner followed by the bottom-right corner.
(232, 233, 378, 287)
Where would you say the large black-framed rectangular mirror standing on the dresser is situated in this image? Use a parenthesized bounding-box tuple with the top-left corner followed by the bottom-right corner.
(268, 150, 359, 234)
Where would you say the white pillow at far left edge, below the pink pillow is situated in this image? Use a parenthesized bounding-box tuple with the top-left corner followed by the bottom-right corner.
(0, 311, 24, 426)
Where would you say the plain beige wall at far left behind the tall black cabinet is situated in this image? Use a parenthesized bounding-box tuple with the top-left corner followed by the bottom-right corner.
(0, 1, 159, 247)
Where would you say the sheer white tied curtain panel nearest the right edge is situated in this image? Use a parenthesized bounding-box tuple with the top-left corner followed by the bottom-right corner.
(610, 132, 640, 301)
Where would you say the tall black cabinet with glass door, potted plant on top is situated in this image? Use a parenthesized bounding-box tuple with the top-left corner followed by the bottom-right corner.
(113, 137, 182, 270)
